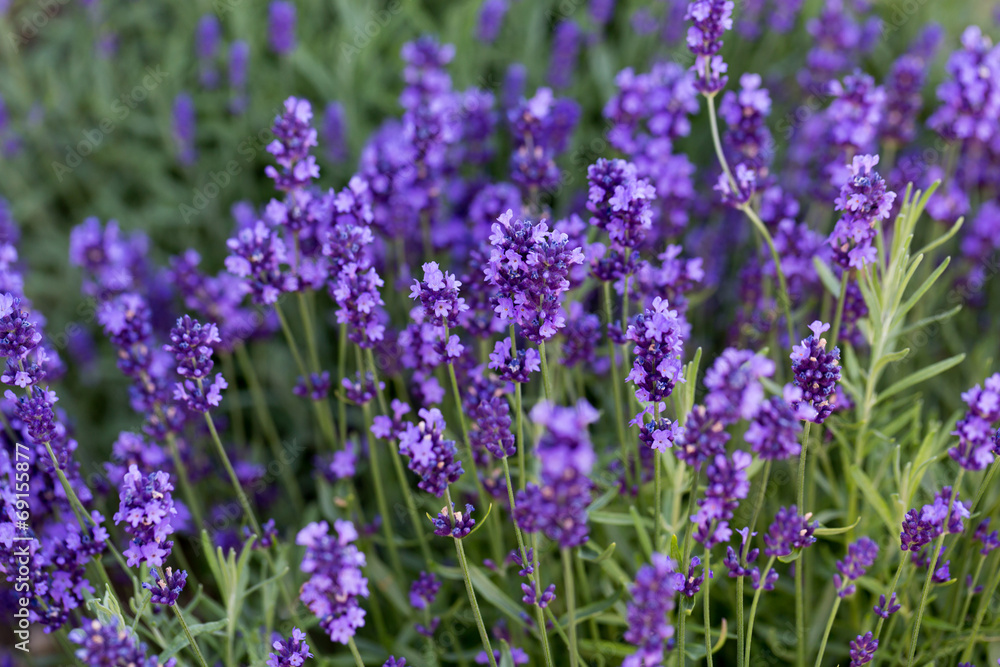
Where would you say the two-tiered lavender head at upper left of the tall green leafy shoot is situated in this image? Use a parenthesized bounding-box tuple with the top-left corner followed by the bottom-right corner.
(830, 155, 896, 269)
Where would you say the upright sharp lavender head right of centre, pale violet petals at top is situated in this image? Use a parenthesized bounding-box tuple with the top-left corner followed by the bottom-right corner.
(625, 297, 684, 403)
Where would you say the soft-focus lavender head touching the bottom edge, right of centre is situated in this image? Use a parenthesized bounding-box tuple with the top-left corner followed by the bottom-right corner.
(622, 553, 684, 667)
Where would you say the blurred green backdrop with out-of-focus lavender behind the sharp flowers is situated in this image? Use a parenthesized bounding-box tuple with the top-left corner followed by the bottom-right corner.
(0, 0, 996, 472)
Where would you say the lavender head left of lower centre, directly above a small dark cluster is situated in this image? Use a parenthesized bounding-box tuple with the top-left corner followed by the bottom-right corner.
(399, 408, 463, 498)
